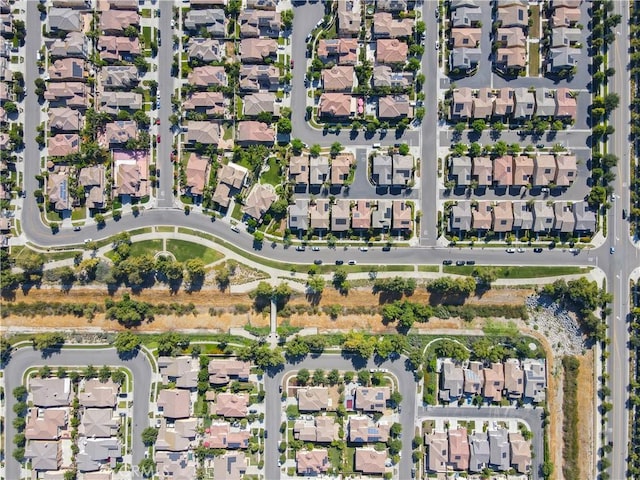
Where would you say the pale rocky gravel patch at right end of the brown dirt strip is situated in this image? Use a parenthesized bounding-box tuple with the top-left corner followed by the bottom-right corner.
(525, 295, 586, 356)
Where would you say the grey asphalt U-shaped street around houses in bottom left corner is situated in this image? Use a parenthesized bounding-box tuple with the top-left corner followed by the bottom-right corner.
(4, 346, 152, 479)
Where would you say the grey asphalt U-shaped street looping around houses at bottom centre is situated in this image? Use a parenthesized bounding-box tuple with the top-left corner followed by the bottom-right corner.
(264, 354, 416, 480)
